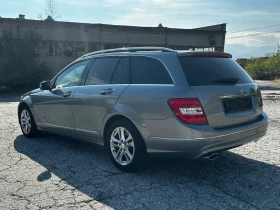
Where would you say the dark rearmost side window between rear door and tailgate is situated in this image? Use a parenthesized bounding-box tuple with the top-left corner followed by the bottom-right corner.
(131, 57, 173, 84)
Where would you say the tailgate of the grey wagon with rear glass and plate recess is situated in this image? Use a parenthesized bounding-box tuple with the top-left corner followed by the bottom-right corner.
(179, 55, 262, 128)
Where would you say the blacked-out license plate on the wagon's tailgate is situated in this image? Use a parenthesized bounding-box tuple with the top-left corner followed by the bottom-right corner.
(223, 97, 253, 113)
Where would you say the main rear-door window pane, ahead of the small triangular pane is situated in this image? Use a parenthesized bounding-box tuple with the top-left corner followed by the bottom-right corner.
(85, 58, 120, 85)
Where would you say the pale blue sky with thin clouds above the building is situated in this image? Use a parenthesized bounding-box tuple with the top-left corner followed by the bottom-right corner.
(0, 0, 280, 58)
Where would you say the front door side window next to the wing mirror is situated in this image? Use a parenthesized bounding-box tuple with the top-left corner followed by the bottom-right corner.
(54, 60, 89, 88)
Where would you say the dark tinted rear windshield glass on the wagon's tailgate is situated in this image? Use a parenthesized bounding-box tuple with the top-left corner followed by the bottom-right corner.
(179, 56, 253, 86)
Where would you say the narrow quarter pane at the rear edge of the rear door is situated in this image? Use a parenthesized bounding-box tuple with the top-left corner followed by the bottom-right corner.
(111, 58, 130, 84)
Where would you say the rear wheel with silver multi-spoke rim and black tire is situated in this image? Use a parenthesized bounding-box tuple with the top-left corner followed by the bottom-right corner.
(107, 120, 148, 172)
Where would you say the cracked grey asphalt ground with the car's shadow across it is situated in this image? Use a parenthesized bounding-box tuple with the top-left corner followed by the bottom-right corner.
(0, 96, 280, 210)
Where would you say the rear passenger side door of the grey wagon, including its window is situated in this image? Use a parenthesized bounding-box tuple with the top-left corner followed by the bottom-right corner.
(72, 57, 130, 144)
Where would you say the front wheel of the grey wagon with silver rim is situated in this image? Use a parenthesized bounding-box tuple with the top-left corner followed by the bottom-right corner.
(19, 106, 39, 138)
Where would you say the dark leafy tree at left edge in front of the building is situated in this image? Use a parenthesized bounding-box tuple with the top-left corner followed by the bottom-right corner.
(0, 30, 51, 88)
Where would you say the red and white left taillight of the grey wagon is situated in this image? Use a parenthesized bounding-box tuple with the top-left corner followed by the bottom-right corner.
(168, 98, 208, 125)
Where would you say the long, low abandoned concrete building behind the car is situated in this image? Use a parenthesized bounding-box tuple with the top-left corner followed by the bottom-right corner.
(0, 15, 226, 72)
